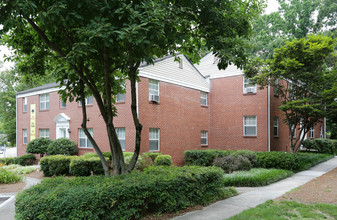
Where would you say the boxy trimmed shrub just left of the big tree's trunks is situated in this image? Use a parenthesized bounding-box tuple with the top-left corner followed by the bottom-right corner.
(69, 156, 110, 176)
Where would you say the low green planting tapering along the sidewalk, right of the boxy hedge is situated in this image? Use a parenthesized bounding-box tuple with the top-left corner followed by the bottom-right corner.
(296, 153, 333, 172)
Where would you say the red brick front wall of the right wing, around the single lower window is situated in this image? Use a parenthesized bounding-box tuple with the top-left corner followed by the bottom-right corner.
(210, 75, 268, 151)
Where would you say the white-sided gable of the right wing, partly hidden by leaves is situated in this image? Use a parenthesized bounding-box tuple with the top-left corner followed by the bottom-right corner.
(195, 52, 244, 79)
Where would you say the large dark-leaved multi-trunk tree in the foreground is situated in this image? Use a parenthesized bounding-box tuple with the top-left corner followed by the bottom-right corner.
(0, 0, 263, 175)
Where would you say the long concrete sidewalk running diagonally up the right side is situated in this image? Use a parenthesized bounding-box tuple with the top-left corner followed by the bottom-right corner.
(174, 157, 337, 220)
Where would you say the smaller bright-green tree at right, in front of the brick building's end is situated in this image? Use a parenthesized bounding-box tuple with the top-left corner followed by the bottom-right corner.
(247, 35, 336, 153)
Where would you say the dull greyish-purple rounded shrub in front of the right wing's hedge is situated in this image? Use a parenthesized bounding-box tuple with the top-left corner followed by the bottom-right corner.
(213, 155, 252, 173)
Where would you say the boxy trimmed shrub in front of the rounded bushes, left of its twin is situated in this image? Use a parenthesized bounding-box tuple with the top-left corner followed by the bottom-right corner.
(40, 155, 74, 176)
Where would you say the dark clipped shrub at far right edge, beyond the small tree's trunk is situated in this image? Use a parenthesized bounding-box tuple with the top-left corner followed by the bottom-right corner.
(302, 139, 337, 155)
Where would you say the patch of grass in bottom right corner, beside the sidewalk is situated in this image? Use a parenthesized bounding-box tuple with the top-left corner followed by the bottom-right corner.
(229, 200, 337, 220)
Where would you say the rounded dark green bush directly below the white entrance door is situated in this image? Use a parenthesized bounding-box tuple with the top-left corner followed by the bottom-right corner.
(47, 138, 78, 155)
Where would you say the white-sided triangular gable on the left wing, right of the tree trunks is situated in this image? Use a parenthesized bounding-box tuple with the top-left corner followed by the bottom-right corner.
(139, 55, 210, 92)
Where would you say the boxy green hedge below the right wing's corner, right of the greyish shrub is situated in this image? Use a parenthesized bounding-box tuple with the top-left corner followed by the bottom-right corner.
(256, 151, 299, 171)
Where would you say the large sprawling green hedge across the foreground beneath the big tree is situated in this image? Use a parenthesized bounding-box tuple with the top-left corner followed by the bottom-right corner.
(15, 166, 234, 219)
